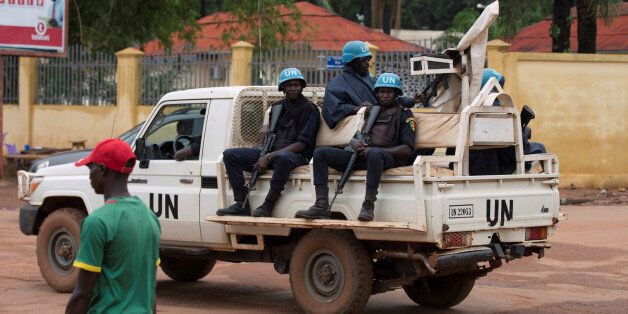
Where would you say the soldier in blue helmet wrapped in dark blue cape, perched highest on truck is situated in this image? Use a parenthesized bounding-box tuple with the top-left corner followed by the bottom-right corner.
(322, 40, 419, 128)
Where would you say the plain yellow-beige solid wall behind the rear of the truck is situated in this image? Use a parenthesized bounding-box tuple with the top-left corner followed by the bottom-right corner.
(489, 41, 628, 188)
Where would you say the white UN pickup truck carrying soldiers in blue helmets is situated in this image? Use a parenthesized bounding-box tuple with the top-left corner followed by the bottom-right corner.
(18, 2, 564, 312)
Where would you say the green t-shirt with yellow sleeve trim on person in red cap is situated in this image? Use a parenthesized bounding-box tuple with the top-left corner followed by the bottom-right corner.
(74, 197, 161, 313)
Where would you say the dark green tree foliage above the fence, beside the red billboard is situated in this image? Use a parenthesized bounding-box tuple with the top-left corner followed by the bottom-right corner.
(69, 0, 198, 52)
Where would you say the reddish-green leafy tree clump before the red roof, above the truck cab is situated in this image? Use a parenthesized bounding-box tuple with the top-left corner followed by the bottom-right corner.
(222, 0, 304, 49)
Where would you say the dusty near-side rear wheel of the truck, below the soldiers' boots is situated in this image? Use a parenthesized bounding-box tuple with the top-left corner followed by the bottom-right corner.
(290, 230, 373, 313)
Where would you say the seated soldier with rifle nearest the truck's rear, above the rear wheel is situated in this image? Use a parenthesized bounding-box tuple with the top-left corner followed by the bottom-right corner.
(295, 73, 416, 221)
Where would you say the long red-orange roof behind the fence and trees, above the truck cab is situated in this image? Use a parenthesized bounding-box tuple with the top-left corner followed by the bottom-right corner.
(144, 2, 422, 54)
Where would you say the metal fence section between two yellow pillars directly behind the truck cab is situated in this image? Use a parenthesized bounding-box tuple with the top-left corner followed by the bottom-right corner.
(141, 50, 231, 105)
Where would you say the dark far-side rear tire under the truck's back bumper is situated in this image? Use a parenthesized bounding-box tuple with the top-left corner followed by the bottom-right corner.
(403, 277, 475, 309)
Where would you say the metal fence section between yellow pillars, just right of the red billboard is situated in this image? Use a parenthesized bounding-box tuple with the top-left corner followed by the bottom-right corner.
(36, 45, 116, 106)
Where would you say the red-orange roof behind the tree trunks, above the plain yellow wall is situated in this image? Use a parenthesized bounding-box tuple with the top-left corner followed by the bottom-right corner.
(508, 2, 628, 53)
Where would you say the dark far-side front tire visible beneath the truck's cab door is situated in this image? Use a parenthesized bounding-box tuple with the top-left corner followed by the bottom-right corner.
(160, 255, 216, 282)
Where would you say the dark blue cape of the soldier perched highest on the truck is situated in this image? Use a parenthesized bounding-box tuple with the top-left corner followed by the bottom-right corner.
(323, 67, 414, 129)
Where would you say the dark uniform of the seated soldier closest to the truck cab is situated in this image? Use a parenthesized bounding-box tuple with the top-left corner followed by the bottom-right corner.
(223, 96, 320, 192)
